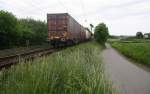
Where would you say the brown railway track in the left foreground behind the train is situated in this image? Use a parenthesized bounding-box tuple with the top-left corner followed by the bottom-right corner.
(0, 47, 60, 69)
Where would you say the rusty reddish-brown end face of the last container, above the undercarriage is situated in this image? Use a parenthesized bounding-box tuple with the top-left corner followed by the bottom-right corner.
(47, 14, 68, 40)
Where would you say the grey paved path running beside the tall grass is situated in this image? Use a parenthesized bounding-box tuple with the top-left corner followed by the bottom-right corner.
(102, 44, 150, 94)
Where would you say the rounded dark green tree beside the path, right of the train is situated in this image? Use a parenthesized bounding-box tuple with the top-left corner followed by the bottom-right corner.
(94, 23, 109, 44)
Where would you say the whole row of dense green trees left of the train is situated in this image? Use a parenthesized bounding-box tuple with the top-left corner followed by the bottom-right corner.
(0, 10, 47, 48)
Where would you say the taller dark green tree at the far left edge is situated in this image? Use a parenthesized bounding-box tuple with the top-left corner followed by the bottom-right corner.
(0, 10, 21, 46)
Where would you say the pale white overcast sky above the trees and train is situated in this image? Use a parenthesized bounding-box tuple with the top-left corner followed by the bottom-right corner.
(0, 0, 150, 35)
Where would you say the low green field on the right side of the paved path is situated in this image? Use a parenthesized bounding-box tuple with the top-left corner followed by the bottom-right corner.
(112, 41, 150, 65)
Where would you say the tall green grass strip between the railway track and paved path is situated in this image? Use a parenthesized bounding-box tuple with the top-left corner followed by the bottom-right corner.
(0, 42, 115, 94)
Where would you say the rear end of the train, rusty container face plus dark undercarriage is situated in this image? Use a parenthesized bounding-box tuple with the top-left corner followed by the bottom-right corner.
(47, 13, 68, 46)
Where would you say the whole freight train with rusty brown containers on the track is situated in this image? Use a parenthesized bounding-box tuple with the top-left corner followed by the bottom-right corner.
(47, 13, 92, 46)
